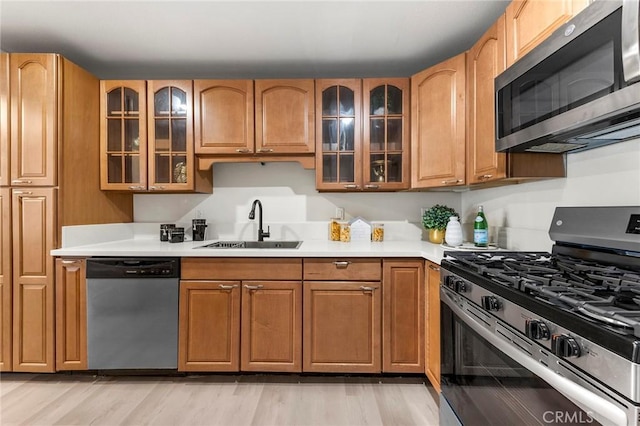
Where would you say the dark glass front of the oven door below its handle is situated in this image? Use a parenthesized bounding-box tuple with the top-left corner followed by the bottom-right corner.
(440, 303, 599, 425)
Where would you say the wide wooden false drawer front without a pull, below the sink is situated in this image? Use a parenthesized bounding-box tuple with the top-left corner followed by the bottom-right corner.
(180, 257, 302, 280)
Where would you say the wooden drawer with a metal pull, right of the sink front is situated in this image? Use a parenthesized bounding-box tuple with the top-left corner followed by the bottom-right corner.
(304, 258, 382, 281)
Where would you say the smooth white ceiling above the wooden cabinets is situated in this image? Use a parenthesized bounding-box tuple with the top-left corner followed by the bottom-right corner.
(0, 0, 509, 79)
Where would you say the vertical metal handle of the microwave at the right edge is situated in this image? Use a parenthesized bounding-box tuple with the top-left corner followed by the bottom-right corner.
(621, 0, 640, 83)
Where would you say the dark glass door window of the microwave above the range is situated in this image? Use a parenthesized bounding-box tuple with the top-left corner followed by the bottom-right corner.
(498, 9, 624, 138)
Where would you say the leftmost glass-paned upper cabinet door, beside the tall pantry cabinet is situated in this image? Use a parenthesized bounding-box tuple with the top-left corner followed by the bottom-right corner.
(100, 80, 147, 191)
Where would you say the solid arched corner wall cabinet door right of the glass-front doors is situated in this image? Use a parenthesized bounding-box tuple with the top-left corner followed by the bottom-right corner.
(411, 53, 466, 188)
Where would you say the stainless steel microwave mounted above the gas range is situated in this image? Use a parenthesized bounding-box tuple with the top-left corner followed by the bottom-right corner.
(495, 0, 640, 153)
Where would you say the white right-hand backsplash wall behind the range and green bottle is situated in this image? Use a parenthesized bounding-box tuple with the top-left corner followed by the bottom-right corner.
(462, 139, 640, 251)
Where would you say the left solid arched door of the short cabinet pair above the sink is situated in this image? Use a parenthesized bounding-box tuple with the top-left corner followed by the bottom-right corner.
(193, 80, 254, 154)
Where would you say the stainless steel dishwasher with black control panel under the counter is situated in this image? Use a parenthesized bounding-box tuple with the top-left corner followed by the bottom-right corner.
(87, 257, 180, 370)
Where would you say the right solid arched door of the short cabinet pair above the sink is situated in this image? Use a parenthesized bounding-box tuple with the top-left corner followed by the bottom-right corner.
(255, 79, 315, 154)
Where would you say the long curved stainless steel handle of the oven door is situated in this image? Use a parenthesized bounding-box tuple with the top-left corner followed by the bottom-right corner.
(440, 288, 629, 425)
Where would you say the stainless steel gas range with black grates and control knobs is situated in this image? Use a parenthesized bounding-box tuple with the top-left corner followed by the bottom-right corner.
(440, 207, 640, 426)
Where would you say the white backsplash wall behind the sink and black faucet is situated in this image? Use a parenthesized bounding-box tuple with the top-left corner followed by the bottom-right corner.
(134, 162, 461, 239)
